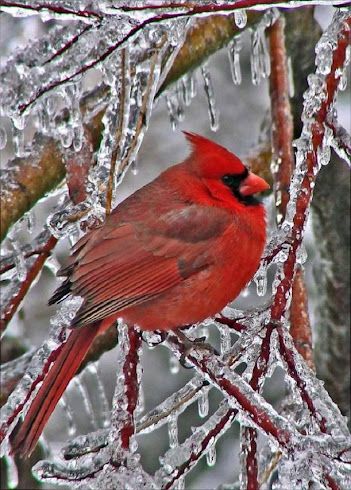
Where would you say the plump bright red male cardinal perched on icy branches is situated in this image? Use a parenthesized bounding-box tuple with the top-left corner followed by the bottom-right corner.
(12, 132, 269, 455)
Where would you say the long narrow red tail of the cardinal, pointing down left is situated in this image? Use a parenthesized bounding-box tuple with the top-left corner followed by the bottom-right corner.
(12, 322, 106, 456)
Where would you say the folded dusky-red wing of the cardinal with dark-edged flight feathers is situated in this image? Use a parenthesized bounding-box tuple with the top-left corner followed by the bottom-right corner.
(50, 205, 231, 327)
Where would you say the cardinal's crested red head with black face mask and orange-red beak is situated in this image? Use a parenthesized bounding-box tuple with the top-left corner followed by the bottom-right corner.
(184, 131, 269, 205)
